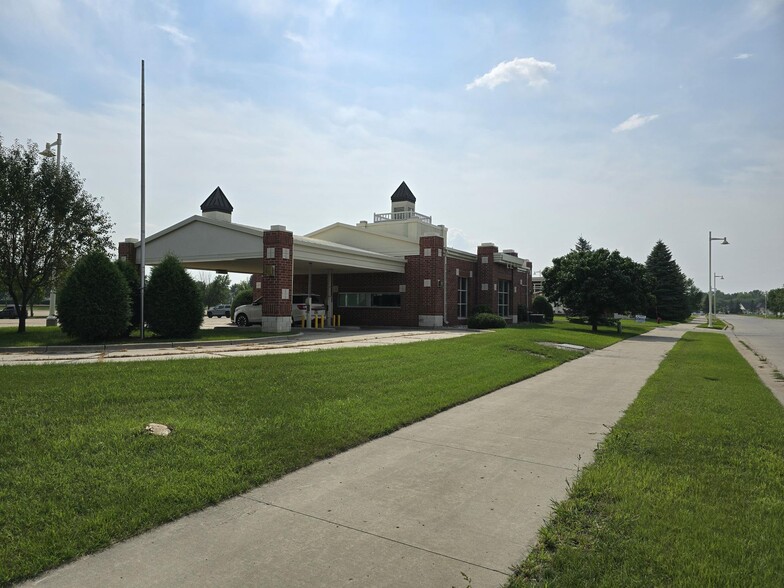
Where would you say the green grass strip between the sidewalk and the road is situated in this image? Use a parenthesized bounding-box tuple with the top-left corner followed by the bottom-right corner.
(509, 333, 784, 587)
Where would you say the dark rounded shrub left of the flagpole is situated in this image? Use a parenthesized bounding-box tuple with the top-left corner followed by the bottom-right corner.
(57, 251, 131, 341)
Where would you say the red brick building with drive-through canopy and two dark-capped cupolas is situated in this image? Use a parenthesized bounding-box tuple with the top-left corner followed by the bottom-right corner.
(119, 182, 533, 332)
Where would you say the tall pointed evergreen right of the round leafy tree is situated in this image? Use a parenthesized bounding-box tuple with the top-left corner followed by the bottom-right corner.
(645, 240, 690, 321)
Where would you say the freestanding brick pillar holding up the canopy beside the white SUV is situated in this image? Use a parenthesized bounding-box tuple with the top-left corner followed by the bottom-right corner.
(260, 225, 294, 333)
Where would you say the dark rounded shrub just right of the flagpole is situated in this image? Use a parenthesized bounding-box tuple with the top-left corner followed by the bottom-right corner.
(144, 255, 204, 339)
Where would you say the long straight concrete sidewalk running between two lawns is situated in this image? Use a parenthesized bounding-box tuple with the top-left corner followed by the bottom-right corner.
(26, 325, 694, 588)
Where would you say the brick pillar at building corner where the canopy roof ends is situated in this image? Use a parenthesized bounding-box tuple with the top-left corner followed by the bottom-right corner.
(405, 236, 446, 327)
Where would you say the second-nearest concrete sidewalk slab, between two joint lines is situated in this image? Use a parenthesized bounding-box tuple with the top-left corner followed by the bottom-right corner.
(247, 437, 574, 573)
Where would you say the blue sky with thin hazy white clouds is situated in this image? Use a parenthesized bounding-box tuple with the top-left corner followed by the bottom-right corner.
(0, 0, 784, 292)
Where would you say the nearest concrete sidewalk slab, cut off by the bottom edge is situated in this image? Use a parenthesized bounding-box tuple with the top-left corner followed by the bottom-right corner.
(28, 498, 505, 588)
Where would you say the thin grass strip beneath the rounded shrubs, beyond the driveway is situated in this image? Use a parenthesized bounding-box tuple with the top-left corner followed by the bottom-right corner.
(0, 326, 277, 347)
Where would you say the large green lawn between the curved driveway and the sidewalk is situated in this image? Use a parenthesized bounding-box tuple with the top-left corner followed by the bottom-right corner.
(0, 323, 653, 584)
